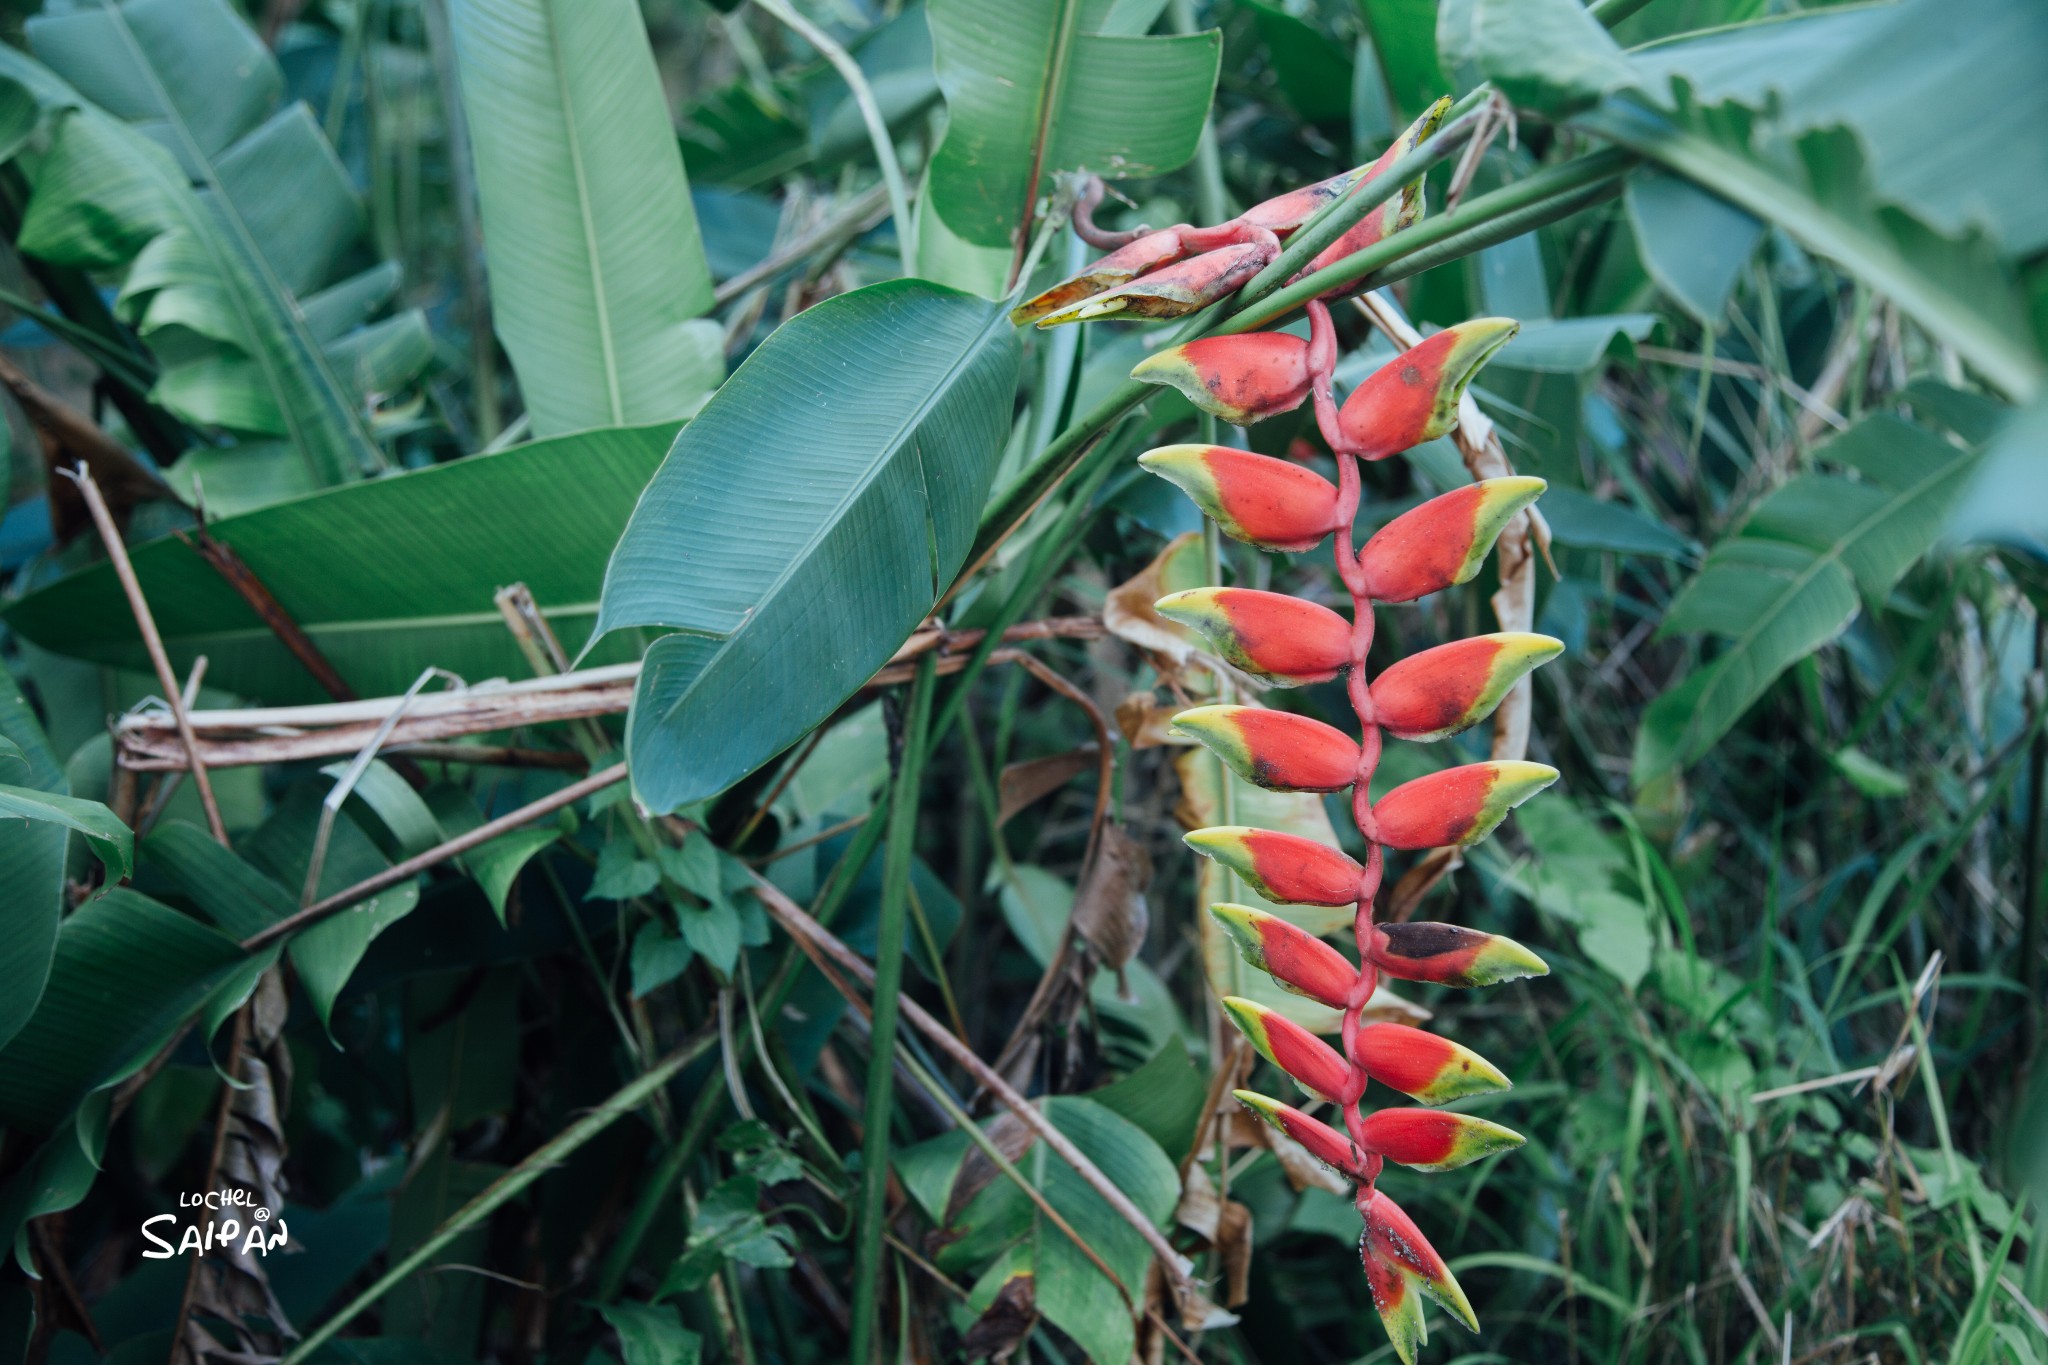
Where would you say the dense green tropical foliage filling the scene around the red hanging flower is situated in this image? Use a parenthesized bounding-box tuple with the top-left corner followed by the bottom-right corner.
(0, 0, 2048, 1365)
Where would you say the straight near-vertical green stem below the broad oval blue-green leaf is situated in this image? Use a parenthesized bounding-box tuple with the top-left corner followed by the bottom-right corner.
(846, 653, 938, 1365)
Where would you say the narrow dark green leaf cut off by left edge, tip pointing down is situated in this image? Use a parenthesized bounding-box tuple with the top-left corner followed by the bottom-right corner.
(0, 667, 70, 1046)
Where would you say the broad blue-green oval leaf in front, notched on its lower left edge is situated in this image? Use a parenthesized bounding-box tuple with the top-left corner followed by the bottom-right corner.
(598, 280, 1018, 810)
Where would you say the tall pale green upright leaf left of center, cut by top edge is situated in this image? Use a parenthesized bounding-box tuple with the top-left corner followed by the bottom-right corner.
(451, 0, 725, 436)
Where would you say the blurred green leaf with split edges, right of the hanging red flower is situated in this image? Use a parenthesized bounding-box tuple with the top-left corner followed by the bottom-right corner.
(1634, 413, 1978, 784)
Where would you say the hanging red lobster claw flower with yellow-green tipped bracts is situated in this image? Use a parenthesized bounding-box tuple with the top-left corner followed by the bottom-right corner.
(1016, 90, 1563, 1363)
